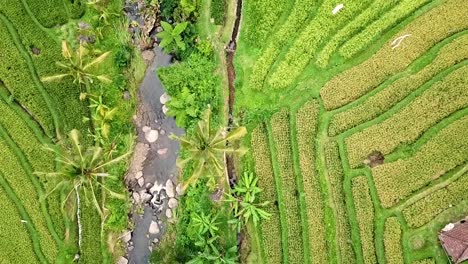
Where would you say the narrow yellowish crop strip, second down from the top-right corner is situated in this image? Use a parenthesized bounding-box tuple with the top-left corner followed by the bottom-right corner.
(328, 35, 468, 136)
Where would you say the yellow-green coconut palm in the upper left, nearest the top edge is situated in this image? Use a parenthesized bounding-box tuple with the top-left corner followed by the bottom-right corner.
(41, 41, 112, 87)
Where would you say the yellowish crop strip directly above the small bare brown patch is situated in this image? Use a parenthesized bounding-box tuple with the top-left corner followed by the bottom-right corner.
(345, 66, 468, 167)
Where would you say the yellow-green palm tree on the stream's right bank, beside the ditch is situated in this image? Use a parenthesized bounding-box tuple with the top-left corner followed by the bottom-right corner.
(171, 107, 247, 190)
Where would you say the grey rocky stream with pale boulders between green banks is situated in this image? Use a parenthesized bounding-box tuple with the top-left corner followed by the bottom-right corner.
(123, 48, 183, 264)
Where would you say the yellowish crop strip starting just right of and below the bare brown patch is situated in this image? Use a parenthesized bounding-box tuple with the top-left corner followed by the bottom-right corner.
(372, 116, 468, 208)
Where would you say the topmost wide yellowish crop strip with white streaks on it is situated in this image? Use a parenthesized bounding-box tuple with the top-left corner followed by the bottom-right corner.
(320, 0, 468, 110)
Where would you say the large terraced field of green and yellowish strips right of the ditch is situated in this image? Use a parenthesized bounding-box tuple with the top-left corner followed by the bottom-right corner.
(235, 0, 468, 263)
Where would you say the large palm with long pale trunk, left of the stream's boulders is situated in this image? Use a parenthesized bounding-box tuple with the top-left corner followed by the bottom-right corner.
(35, 129, 130, 250)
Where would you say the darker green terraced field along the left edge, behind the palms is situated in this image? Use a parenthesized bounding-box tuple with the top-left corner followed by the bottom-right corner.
(0, 0, 102, 264)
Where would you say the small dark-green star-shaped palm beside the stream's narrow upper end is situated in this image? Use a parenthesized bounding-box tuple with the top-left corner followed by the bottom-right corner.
(156, 21, 188, 52)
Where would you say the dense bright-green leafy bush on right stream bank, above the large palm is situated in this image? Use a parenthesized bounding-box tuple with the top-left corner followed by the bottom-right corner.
(158, 53, 221, 128)
